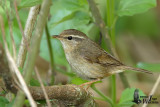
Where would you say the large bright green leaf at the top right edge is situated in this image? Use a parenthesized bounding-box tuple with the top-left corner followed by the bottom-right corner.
(117, 0, 156, 16)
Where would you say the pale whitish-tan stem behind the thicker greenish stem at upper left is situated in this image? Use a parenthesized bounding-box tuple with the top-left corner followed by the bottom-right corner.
(17, 5, 40, 68)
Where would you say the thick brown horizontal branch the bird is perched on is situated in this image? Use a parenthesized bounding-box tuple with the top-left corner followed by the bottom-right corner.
(30, 85, 96, 107)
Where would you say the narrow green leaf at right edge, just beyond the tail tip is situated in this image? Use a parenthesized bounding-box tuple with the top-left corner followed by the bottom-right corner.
(137, 62, 160, 72)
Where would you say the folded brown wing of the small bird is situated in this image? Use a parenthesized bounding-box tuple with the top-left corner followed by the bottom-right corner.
(78, 40, 122, 66)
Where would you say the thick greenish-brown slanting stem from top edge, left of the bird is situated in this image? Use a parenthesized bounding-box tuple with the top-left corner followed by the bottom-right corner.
(13, 0, 52, 107)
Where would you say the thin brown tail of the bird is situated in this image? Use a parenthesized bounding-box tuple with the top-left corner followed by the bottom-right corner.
(120, 66, 153, 74)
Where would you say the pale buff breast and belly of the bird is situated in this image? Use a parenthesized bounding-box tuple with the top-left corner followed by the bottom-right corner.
(66, 53, 106, 80)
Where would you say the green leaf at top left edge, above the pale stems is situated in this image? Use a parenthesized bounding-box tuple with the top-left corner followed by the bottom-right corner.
(18, 0, 42, 9)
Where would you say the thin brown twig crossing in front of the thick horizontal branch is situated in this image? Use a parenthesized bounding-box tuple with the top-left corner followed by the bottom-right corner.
(35, 67, 52, 107)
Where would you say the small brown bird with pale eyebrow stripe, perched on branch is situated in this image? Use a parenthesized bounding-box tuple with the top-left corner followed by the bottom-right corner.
(52, 29, 152, 84)
